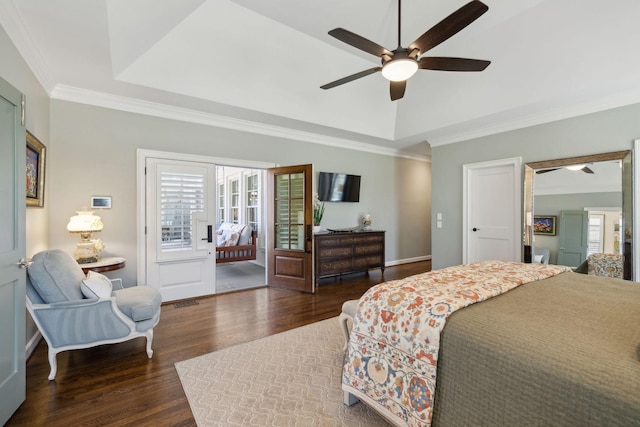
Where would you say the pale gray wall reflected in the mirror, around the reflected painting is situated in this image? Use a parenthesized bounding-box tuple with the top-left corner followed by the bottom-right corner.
(533, 193, 622, 264)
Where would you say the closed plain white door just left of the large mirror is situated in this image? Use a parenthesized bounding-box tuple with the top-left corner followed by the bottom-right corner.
(462, 158, 522, 264)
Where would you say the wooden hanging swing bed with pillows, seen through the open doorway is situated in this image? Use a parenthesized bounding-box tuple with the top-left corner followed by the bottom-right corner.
(216, 223, 258, 264)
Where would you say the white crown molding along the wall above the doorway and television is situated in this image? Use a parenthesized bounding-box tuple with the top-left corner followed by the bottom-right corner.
(50, 85, 431, 162)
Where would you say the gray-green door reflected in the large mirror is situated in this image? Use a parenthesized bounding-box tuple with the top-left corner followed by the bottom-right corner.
(558, 211, 589, 267)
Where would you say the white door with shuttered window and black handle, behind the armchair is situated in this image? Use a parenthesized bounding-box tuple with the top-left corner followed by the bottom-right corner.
(145, 158, 216, 301)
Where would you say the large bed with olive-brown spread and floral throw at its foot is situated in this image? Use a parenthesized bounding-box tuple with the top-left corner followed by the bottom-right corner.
(343, 262, 640, 427)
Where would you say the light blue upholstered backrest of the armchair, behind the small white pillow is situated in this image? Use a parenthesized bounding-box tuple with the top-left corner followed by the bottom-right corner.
(28, 249, 85, 304)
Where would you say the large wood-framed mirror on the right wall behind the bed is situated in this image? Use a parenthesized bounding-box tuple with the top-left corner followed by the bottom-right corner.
(522, 150, 633, 280)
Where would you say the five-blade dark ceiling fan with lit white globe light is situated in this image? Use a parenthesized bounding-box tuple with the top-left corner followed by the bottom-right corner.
(320, 0, 491, 101)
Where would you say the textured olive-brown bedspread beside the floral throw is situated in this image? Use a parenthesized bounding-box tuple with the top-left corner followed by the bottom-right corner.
(433, 272, 640, 427)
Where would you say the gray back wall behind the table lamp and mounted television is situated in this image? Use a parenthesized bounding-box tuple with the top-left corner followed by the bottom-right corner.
(50, 100, 431, 284)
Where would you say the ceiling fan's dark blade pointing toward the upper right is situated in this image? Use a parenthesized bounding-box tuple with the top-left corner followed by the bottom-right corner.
(409, 0, 489, 54)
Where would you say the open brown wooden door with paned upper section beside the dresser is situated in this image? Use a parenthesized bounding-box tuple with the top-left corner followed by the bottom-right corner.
(267, 165, 315, 292)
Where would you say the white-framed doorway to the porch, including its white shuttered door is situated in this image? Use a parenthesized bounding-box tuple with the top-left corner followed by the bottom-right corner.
(137, 150, 273, 302)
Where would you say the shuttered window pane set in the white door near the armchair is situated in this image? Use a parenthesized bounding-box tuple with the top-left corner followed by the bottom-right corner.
(160, 172, 205, 251)
